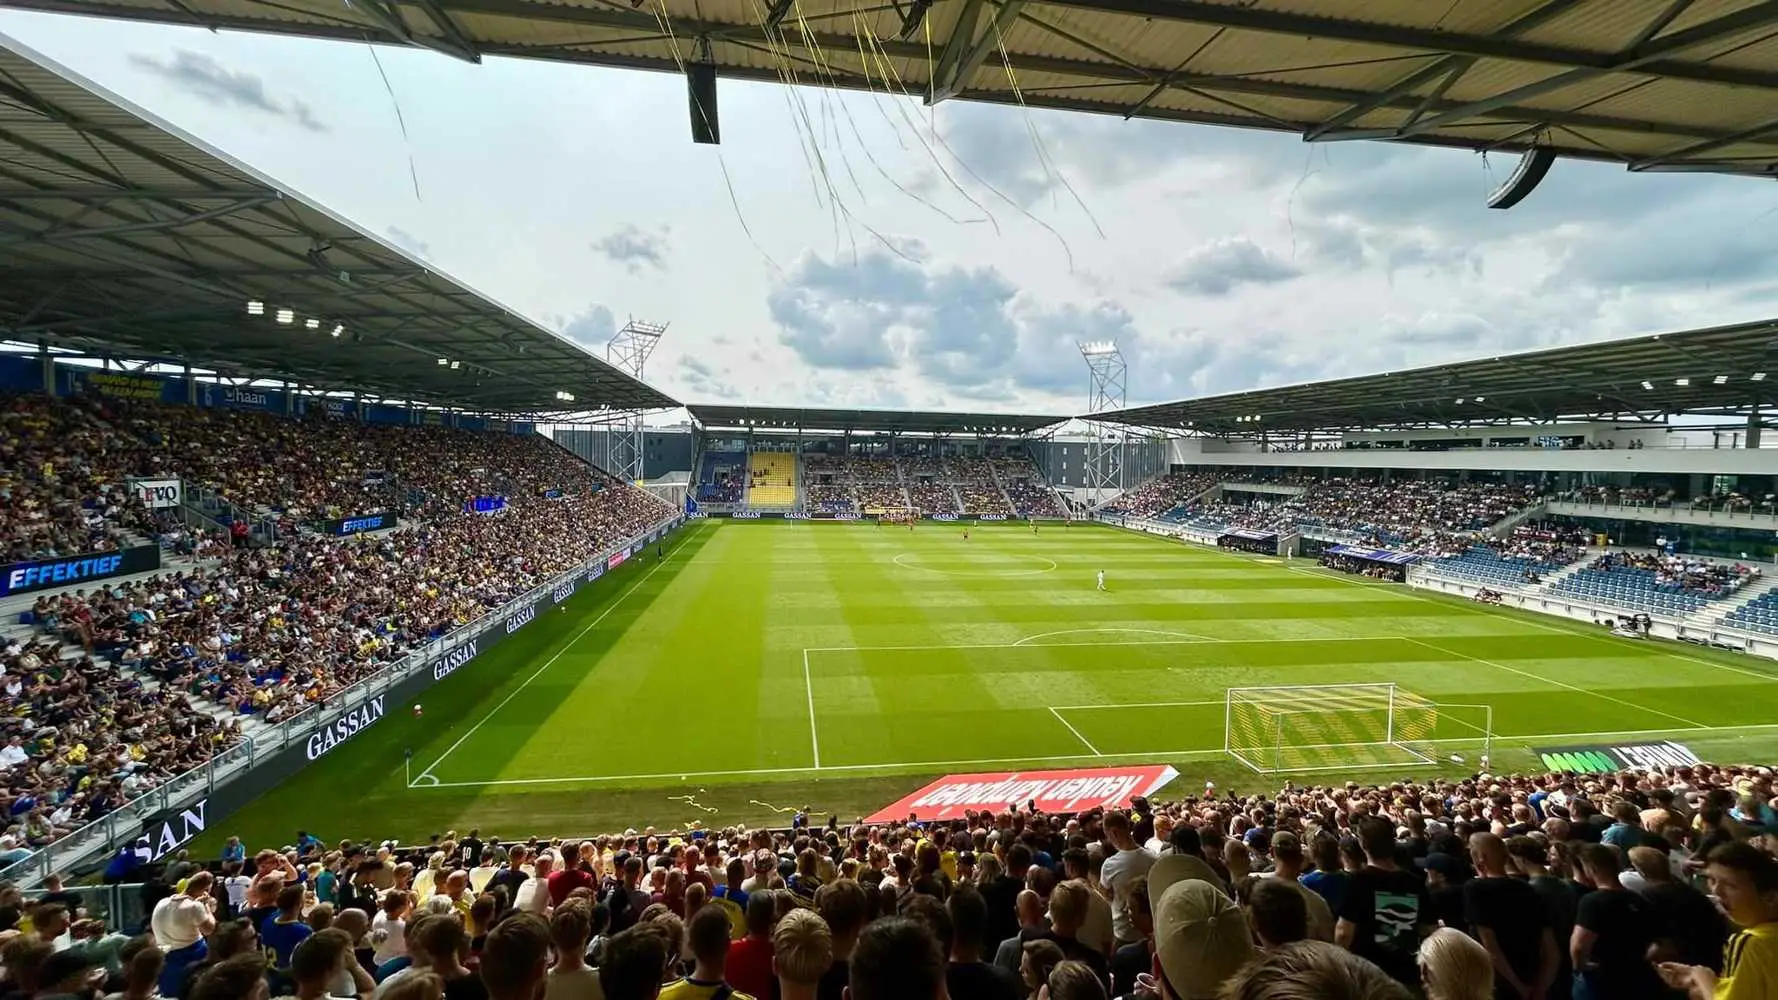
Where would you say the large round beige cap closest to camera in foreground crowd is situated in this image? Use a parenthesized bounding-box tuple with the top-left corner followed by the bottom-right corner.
(1150, 865, 1253, 1000)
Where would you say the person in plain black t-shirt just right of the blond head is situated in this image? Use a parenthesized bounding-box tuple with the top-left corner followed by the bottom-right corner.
(1463, 833, 1558, 1000)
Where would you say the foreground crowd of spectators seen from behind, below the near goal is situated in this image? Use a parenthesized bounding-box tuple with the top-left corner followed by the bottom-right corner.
(45, 765, 1778, 1000)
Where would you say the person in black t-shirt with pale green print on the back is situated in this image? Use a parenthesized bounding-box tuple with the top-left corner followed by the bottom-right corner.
(1334, 817, 1433, 988)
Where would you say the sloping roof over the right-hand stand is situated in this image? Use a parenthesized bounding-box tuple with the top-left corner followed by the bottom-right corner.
(1095, 320, 1778, 436)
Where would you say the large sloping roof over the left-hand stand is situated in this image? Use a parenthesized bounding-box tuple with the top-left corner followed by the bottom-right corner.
(0, 36, 677, 415)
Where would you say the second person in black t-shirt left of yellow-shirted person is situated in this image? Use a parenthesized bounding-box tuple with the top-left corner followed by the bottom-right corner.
(1568, 843, 1666, 1000)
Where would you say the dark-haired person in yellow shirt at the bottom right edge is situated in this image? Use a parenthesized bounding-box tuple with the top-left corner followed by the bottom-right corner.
(1661, 842, 1778, 1000)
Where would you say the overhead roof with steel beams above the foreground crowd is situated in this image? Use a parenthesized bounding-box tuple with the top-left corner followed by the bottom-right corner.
(20, 0, 1778, 176)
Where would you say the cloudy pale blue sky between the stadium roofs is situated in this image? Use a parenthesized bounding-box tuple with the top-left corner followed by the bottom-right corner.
(0, 12, 1778, 411)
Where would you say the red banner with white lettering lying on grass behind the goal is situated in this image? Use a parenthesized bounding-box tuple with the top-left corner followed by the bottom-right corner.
(864, 763, 1179, 822)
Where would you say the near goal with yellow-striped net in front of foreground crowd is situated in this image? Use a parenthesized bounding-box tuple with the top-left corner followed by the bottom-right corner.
(1223, 683, 1494, 774)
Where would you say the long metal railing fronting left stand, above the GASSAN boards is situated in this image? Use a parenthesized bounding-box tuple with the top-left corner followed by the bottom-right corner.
(0, 512, 679, 886)
